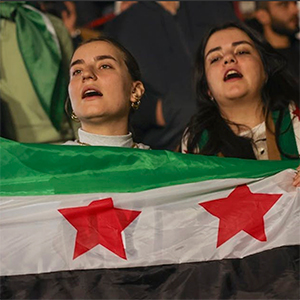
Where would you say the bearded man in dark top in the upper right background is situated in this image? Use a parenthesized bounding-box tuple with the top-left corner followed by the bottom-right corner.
(255, 1, 300, 82)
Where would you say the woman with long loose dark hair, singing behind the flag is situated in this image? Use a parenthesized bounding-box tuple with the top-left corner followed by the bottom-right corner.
(181, 23, 300, 185)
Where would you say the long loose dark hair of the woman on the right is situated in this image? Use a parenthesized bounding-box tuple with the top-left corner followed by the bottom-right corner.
(185, 22, 299, 159)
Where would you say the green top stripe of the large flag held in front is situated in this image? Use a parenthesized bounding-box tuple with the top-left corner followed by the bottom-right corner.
(0, 139, 300, 196)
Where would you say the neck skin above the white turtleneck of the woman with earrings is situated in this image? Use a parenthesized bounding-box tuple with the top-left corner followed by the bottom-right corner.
(81, 120, 128, 136)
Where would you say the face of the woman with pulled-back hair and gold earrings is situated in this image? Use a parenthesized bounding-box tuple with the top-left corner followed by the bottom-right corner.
(69, 41, 135, 125)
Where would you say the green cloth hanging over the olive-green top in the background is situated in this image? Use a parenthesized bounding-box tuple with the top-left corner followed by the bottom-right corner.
(0, 2, 67, 129)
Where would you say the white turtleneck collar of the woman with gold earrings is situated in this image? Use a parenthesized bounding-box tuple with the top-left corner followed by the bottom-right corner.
(64, 128, 150, 149)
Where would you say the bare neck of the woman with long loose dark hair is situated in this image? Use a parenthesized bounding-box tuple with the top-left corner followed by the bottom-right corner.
(220, 101, 264, 133)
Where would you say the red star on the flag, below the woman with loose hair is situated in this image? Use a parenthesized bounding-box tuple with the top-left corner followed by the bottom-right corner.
(199, 185, 282, 247)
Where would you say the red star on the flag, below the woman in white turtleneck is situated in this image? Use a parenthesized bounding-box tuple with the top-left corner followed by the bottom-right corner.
(58, 198, 141, 259)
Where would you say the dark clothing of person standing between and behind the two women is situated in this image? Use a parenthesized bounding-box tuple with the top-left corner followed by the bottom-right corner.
(104, 1, 236, 150)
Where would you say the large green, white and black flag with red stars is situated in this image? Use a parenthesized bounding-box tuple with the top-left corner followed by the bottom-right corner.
(0, 139, 300, 299)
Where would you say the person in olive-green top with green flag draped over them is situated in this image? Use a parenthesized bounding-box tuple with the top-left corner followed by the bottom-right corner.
(0, 1, 74, 143)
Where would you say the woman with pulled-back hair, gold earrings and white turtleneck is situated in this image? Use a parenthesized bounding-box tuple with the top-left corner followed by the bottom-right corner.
(65, 37, 149, 149)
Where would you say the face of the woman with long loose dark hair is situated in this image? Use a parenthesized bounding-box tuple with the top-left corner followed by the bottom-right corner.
(204, 28, 266, 106)
